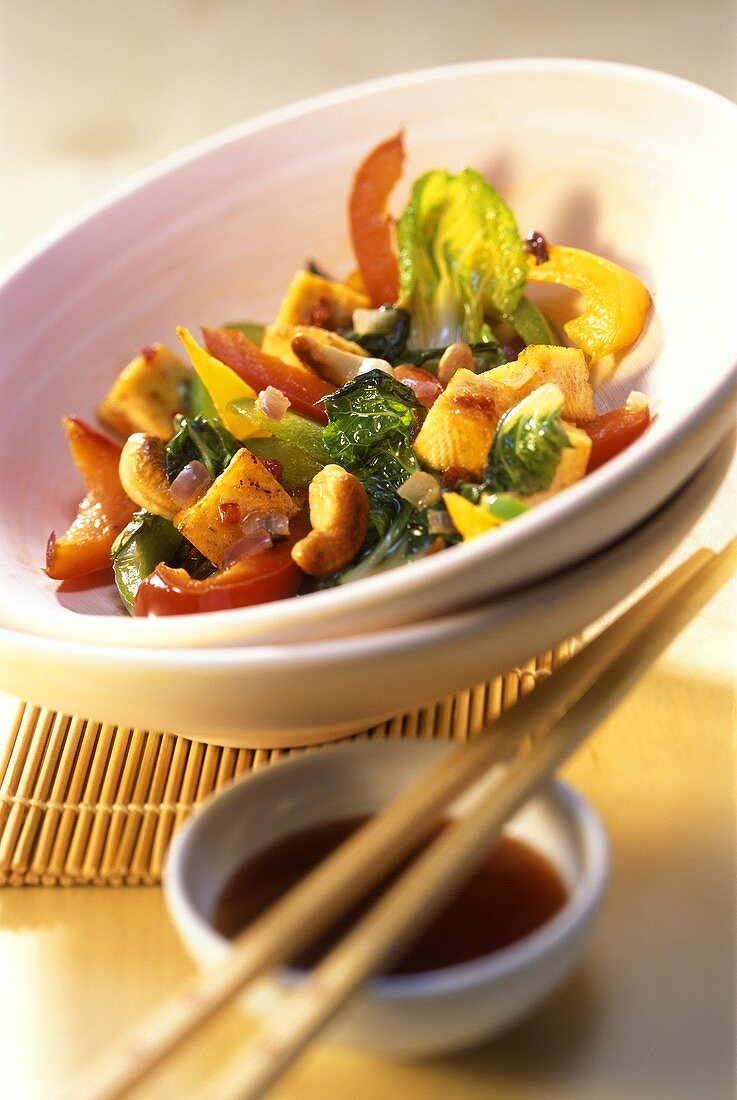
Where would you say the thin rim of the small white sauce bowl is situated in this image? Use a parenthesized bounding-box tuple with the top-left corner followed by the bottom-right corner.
(164, 741, 611, 1001)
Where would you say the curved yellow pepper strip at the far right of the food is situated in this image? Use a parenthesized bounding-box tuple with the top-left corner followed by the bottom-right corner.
(527, 244, 650, 359)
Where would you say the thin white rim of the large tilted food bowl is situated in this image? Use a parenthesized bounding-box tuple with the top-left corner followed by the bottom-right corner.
(0, 58, 737, 649)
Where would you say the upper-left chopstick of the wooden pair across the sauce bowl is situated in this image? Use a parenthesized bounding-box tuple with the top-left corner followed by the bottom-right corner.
(70, 541, 734, 1100)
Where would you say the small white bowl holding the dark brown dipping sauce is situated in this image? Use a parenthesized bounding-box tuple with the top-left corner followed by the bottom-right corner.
(164, 741, 608, 1056)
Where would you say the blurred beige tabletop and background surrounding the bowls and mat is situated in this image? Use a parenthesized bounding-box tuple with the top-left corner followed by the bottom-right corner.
(0, 0, 737, 1100)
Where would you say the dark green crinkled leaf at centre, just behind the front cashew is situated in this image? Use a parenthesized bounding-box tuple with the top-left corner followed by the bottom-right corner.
(322, 371, 425, 538)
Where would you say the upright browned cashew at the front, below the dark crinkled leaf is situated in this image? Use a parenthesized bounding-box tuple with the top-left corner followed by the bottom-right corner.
(292, 465, 369, 576)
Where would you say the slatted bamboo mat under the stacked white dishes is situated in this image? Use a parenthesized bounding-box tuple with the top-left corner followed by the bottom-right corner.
(0, 642, 573, 886)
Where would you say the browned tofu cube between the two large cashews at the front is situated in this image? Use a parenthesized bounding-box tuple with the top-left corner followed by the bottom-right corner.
(174, 448, 299, 567)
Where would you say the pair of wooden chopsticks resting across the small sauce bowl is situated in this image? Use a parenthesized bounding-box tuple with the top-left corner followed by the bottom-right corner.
(68, 539, 737, 1100)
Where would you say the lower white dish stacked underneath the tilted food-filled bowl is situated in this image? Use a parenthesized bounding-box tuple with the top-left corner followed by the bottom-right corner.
(0, 432, 735, 748)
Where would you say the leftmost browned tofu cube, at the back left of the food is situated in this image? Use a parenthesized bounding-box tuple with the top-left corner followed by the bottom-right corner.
(97, 344, 191, 439)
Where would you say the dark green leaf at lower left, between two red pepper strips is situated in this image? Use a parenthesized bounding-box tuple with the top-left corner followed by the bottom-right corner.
(110, 512, 215, 613)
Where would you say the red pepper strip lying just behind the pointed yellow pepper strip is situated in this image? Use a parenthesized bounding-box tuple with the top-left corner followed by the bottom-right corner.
(202, 328, 336, 424)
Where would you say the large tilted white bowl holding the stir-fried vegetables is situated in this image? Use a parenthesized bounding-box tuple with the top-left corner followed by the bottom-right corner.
(0, 61, 737, 647)
